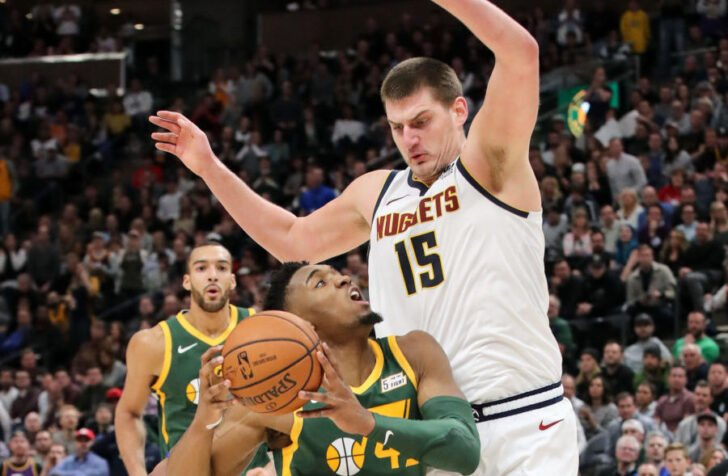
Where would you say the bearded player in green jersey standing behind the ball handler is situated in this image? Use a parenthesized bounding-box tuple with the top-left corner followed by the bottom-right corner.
(116, 242, 264, 476)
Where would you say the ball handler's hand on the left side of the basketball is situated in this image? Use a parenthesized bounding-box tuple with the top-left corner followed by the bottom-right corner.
(195, 345, 238, 430)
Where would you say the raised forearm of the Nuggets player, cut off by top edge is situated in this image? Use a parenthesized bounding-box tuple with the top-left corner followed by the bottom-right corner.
(432, 0, 538, 63)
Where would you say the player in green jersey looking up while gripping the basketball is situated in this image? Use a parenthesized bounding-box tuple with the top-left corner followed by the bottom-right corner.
(167, 263, 480, 476)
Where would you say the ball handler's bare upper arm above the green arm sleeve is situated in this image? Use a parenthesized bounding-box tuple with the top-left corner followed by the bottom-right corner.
(397, 331, 465, 406)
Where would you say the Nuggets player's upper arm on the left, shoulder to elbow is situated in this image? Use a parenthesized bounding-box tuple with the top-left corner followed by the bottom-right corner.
(289, 170, 389, 263)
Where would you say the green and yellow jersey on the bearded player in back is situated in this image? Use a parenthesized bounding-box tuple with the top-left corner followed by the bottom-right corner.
(152, 305, 267, 465)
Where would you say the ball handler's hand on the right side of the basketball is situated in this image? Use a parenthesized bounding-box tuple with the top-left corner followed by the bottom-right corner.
(298, 343, 375, 435)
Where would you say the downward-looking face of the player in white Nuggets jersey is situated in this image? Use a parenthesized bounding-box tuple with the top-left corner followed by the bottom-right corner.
(384, 88, 468, 185)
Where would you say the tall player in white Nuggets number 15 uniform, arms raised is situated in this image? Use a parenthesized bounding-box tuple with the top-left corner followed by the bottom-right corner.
(150, 0, 578, 476)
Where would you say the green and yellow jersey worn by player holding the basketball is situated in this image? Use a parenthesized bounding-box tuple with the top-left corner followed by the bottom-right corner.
(273, 336, 425, 476)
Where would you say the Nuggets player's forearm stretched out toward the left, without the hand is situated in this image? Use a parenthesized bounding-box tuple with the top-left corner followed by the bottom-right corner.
(202, 162, 310, 261)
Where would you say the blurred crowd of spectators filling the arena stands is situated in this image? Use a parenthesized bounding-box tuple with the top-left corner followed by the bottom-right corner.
(0, 0, 728, 476)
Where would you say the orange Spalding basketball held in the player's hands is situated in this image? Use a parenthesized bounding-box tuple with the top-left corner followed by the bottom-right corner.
(222, 311, 322, 414)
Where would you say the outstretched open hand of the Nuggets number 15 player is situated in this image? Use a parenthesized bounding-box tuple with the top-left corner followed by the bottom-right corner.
(149, 111, 217, 176)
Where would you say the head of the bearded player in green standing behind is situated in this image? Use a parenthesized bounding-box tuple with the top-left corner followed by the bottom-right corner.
(182, 246, 235, 312)
